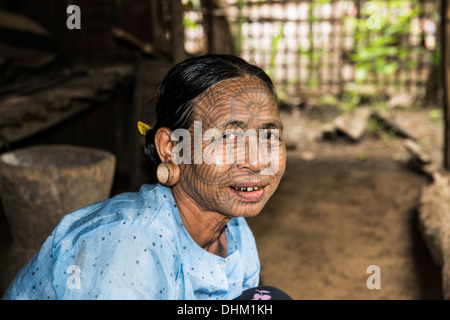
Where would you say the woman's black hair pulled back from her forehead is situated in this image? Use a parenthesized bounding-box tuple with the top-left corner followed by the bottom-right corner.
(144, 54, 277, 180)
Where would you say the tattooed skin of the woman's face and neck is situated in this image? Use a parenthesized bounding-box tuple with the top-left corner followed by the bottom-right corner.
(157, 76, 286, 256)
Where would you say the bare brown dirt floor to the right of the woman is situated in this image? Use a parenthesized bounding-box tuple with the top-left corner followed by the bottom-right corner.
(249, 105, 442, 299)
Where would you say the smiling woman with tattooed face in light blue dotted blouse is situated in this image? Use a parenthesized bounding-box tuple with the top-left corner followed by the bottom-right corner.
(5, 55, 286, 299)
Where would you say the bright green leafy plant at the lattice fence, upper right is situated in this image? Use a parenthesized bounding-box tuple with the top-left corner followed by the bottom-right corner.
(343, 0, 440, 109)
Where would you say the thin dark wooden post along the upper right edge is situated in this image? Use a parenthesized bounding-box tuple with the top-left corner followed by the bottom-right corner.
(441, 0, 450, 169)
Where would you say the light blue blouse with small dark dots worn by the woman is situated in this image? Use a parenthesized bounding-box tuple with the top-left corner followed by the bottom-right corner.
(4, 184, 260, 300)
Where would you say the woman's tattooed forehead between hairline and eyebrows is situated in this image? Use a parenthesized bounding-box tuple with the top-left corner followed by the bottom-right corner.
(195, 77, 278, 125)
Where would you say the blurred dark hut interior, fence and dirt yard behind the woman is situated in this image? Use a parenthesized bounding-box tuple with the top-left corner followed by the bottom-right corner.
(0, 0, 450, 299)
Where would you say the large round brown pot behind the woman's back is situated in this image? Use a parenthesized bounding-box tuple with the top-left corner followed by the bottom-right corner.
(0, 145, 116, 251)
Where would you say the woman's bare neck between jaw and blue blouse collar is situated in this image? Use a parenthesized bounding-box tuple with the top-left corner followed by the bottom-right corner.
(171, 185, 230, 258)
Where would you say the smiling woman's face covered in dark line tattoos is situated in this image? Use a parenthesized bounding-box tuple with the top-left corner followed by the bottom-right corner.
(174, 77, 286, 217)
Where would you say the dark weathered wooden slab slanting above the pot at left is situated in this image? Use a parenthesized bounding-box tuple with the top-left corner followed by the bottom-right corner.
(0, 65, 134, 149)
